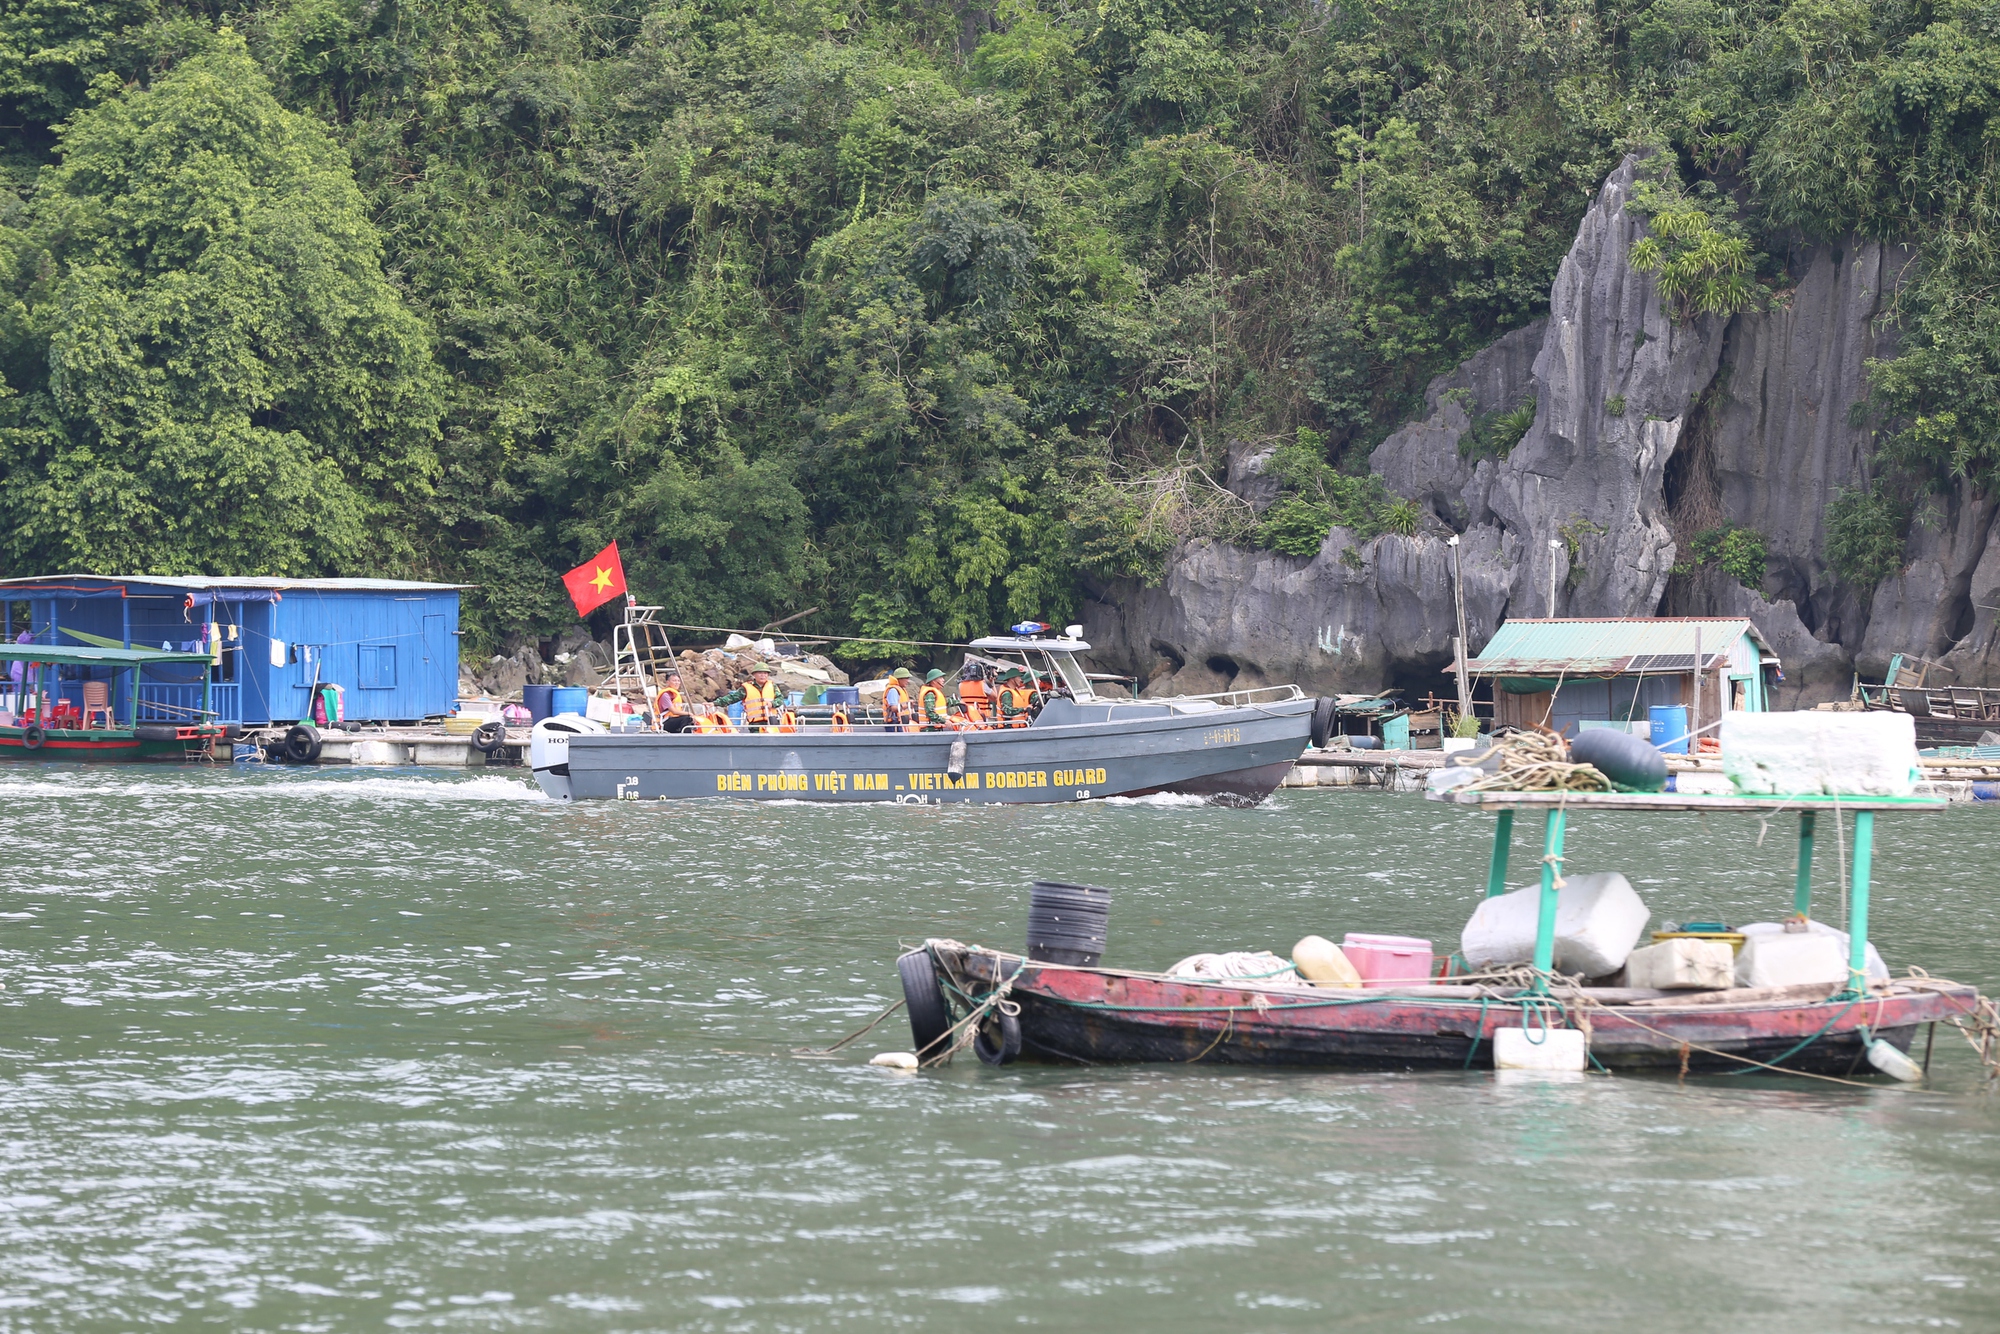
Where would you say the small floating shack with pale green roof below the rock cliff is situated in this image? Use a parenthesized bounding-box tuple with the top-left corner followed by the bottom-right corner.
(1466, 616, 1778, 736)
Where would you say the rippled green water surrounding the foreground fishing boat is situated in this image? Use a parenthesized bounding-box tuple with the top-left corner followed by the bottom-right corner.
(0, 766, 2000, 1334)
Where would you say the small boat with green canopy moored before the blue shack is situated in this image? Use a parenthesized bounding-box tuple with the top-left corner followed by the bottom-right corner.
(0, 644, 234, 760)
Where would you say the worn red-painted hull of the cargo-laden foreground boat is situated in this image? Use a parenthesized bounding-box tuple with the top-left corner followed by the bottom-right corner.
(928, 942, 1976, 1074)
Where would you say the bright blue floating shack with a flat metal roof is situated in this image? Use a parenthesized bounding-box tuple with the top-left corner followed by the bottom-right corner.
(0, 574, 464, 726)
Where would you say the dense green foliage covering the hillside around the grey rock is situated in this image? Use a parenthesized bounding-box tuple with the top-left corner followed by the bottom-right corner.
(0, 0, 2000, 640)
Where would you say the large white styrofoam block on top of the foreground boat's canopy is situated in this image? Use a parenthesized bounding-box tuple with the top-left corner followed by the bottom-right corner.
(1722, 710, 1916, 796)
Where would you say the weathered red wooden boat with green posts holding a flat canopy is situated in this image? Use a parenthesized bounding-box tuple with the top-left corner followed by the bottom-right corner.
(900, 792, 1980, 1076)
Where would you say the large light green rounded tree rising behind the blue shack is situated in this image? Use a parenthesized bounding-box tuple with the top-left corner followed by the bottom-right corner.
(0, 34, 440, 574)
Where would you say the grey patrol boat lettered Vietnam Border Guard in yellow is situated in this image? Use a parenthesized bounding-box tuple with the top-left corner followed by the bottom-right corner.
(528, 624, 1334, 806)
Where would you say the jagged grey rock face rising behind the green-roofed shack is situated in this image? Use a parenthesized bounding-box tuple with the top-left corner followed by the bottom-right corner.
(1086, 158, 2000, 706)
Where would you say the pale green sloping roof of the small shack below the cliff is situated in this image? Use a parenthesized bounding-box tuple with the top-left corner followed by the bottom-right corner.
(1466, 616, 1778, 676)
